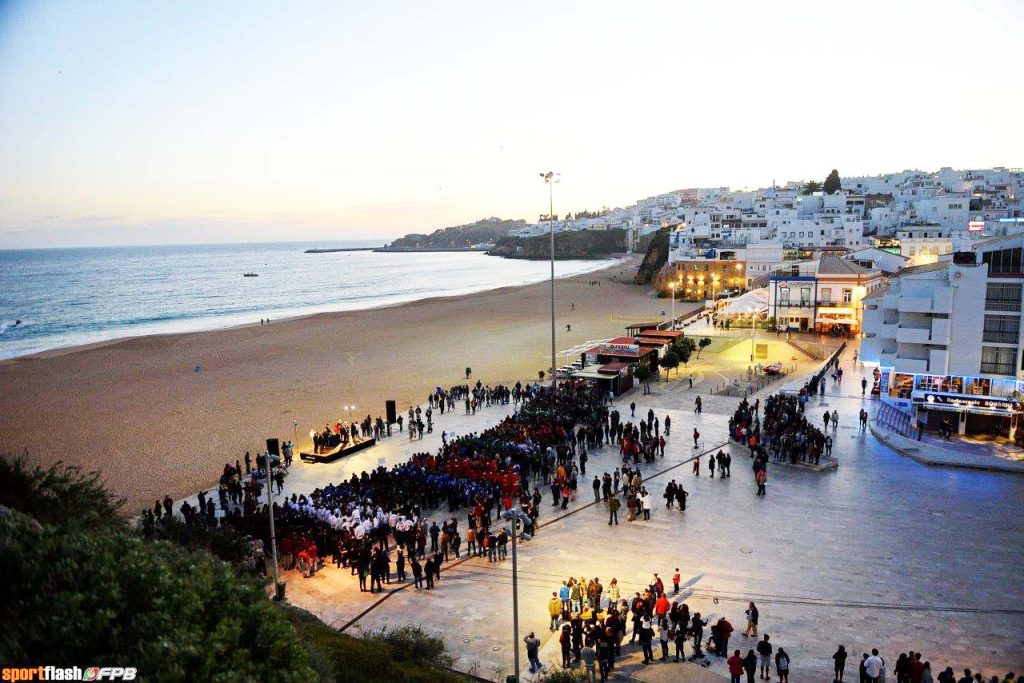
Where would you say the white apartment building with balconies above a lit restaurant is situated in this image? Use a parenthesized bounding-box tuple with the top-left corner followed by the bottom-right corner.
(860, 236, 1024, 437)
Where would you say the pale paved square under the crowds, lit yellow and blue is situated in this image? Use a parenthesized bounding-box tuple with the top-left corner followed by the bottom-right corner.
(272, 354, 1024, 683)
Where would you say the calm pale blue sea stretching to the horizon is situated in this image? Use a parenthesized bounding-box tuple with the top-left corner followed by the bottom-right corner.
(0, 242, 608, 358)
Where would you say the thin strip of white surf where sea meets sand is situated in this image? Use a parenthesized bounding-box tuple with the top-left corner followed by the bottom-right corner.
(0, 254, 622, 362)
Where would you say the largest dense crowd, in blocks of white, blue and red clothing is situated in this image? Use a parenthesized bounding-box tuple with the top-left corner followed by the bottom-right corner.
(142, 382, 607, 592)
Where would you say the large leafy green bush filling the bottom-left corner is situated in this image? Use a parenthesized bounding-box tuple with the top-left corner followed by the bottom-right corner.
(0, 515, 313, 681)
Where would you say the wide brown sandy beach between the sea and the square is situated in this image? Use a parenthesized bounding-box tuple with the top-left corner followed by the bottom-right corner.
(0, 258, 696, 513)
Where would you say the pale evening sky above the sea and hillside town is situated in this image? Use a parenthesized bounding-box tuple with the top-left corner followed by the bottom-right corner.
(0, 0, 1024, 248)
